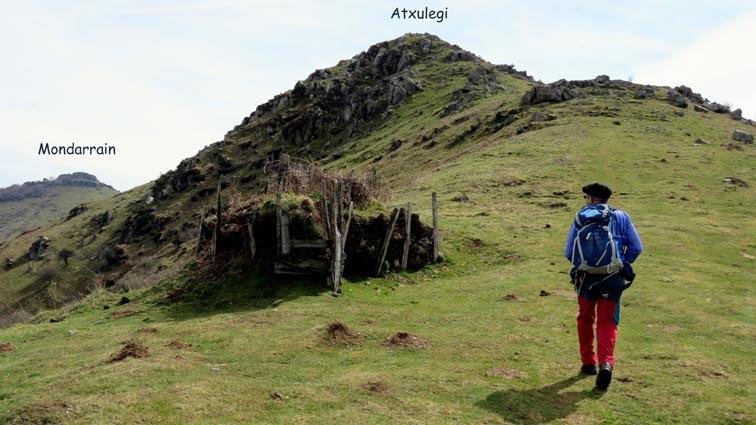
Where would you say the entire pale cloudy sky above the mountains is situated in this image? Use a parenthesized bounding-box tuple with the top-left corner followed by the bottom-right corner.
(0, 0, 756, 190)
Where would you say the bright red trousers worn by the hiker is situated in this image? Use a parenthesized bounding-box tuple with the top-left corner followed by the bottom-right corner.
(578, 295, 619, 367)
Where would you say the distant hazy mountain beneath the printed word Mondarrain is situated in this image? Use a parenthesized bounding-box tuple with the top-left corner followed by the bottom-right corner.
(0, 172, 118, 241)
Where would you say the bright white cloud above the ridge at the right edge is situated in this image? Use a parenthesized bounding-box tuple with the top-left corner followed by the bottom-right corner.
(634, 12, 756, 118)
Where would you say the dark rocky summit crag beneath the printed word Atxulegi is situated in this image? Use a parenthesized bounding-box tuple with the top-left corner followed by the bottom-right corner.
(233, 34, 470, 148)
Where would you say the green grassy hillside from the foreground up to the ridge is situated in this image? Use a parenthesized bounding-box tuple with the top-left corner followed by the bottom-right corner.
(0, 36, 756, 424)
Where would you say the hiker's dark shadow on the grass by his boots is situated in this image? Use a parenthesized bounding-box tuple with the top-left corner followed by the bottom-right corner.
(476, 375, 606, 424)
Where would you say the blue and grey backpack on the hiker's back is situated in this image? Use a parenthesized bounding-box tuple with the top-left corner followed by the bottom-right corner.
(572, 204, 623, 274)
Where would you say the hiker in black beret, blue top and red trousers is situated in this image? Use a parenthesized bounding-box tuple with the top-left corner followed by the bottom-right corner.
(564, 183, 643, 390)
